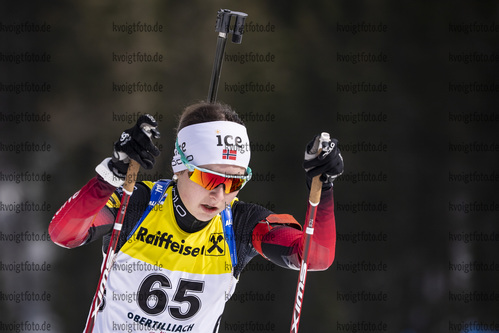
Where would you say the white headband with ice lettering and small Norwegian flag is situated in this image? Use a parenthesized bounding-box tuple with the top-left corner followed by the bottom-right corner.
(172, 121, 251, 173)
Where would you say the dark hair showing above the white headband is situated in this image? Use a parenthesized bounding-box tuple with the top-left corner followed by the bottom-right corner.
(177, 101, 244, 134)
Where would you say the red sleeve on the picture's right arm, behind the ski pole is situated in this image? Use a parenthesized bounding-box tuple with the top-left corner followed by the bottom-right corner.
(252, 188, 336, 271)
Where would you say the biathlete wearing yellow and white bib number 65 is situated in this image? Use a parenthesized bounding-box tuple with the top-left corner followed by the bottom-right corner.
(49, 102, 343, 333)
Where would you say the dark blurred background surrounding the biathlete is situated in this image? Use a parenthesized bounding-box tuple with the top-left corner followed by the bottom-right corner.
(0, 0, 499, 333)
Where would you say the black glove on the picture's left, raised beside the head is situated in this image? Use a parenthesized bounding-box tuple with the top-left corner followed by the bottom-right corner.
(109, 114, 159, 179)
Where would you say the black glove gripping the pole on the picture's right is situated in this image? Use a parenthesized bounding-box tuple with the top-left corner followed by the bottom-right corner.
(303, 134, 343, 189)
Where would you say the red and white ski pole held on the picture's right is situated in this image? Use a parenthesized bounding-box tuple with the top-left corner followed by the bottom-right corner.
(290, 132, 330, 333)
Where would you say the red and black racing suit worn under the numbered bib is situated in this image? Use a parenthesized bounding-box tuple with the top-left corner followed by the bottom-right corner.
(49, 175, 336, 277)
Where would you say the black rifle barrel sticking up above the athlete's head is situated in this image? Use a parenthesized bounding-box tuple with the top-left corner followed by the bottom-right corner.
(208, 9, 248, 103)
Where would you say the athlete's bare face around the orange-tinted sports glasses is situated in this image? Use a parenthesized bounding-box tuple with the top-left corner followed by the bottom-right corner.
(176, 164, 245, 221)
